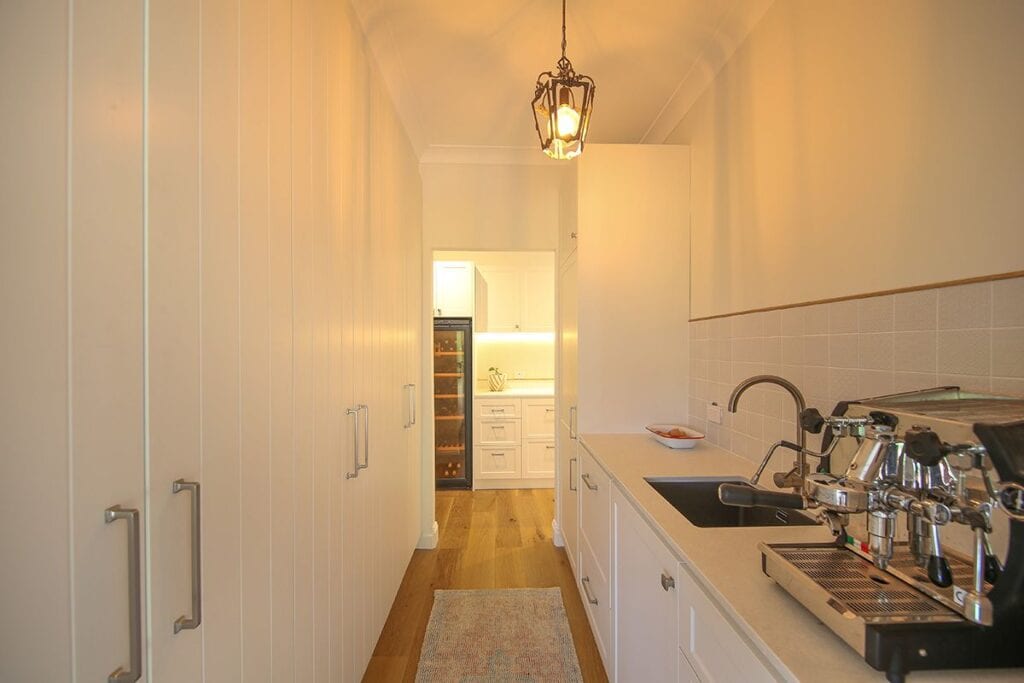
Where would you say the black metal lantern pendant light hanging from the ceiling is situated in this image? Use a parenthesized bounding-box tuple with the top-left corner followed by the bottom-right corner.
(534, 0, 595, 159)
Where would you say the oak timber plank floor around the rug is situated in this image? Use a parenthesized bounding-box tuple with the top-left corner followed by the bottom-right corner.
(362, 488, 608, 682)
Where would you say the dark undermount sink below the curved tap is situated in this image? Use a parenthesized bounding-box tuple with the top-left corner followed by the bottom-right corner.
(645, 477, 817, 527)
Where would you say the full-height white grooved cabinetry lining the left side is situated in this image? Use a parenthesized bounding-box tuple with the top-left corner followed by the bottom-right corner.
(0, 0, 422, 683)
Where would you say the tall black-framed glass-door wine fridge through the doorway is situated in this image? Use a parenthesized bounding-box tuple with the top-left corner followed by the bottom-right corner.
(434, 317, 473, 488)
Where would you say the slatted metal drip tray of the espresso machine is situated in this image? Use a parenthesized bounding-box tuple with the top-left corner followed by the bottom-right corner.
(759, 543, 970, 655)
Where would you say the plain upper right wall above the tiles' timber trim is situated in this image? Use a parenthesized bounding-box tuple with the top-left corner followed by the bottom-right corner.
(668, 0, 1024, 317)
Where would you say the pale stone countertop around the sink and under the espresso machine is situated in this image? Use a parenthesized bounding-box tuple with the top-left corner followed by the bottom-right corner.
(580, 434, 1024, 683)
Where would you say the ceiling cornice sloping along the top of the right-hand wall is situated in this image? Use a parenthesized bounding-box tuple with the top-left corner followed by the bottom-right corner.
(640, 0, 774, 144)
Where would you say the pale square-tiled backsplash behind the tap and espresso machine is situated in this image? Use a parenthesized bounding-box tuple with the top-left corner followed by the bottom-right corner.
(689, 278, 1024, 468)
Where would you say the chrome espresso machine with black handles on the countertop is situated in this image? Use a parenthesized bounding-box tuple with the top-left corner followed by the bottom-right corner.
(719, 387, 1024, 681)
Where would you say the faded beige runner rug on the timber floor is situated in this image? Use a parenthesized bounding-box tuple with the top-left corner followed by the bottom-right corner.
(416, 588, 583, 683)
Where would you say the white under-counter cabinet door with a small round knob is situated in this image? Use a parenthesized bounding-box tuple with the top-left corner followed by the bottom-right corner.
(611, 486, 679, 681)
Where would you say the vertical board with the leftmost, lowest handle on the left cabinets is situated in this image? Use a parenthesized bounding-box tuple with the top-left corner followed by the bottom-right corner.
(69, 0, 146, 681)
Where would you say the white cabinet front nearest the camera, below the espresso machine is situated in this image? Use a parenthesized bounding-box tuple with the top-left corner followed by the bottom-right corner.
(676, 564, 775, 683)
